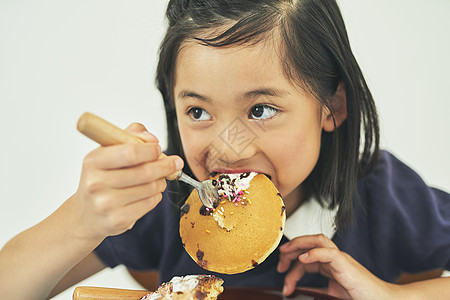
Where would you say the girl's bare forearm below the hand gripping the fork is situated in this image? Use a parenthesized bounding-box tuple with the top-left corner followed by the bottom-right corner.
(0, 195, 101, 299)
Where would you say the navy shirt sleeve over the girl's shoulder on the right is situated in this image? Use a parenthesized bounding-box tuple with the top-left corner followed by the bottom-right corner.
(350, 151, 450, 279)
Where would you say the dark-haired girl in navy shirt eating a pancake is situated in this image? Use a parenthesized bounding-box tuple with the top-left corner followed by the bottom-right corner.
(0, 0, 450, 299)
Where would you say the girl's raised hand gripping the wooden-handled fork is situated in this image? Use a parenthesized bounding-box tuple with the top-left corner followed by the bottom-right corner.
(71, 124, 183, 239)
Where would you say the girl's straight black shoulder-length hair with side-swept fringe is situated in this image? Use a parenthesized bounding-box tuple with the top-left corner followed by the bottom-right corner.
(156, 0, 379, 228)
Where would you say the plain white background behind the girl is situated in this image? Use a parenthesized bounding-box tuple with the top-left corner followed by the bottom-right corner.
(0, 0, 450, 299)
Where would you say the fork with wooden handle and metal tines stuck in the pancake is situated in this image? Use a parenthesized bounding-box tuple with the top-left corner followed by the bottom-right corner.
(77, 112, 219, 208)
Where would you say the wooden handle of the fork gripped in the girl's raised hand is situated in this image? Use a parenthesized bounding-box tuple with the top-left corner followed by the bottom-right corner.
(77, 112, 180, 180)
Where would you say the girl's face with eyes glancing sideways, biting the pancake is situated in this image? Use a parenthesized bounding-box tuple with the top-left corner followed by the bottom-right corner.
(174, 42, 332, 201)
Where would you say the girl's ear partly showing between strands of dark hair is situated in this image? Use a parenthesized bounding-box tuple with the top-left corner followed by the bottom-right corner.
(323, 80, 347, 132)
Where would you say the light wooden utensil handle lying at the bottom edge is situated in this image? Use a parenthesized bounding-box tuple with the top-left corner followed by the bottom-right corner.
(73, 286, 150, 300)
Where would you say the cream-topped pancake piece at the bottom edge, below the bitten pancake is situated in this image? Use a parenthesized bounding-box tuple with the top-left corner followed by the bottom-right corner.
(141, 275, 223, 300)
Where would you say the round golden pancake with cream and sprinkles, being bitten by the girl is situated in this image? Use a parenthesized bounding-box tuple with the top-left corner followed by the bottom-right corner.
(180, 172, 286, 274)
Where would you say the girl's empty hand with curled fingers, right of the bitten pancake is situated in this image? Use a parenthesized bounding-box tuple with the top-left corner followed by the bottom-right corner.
(278, 234, 393, 299)
